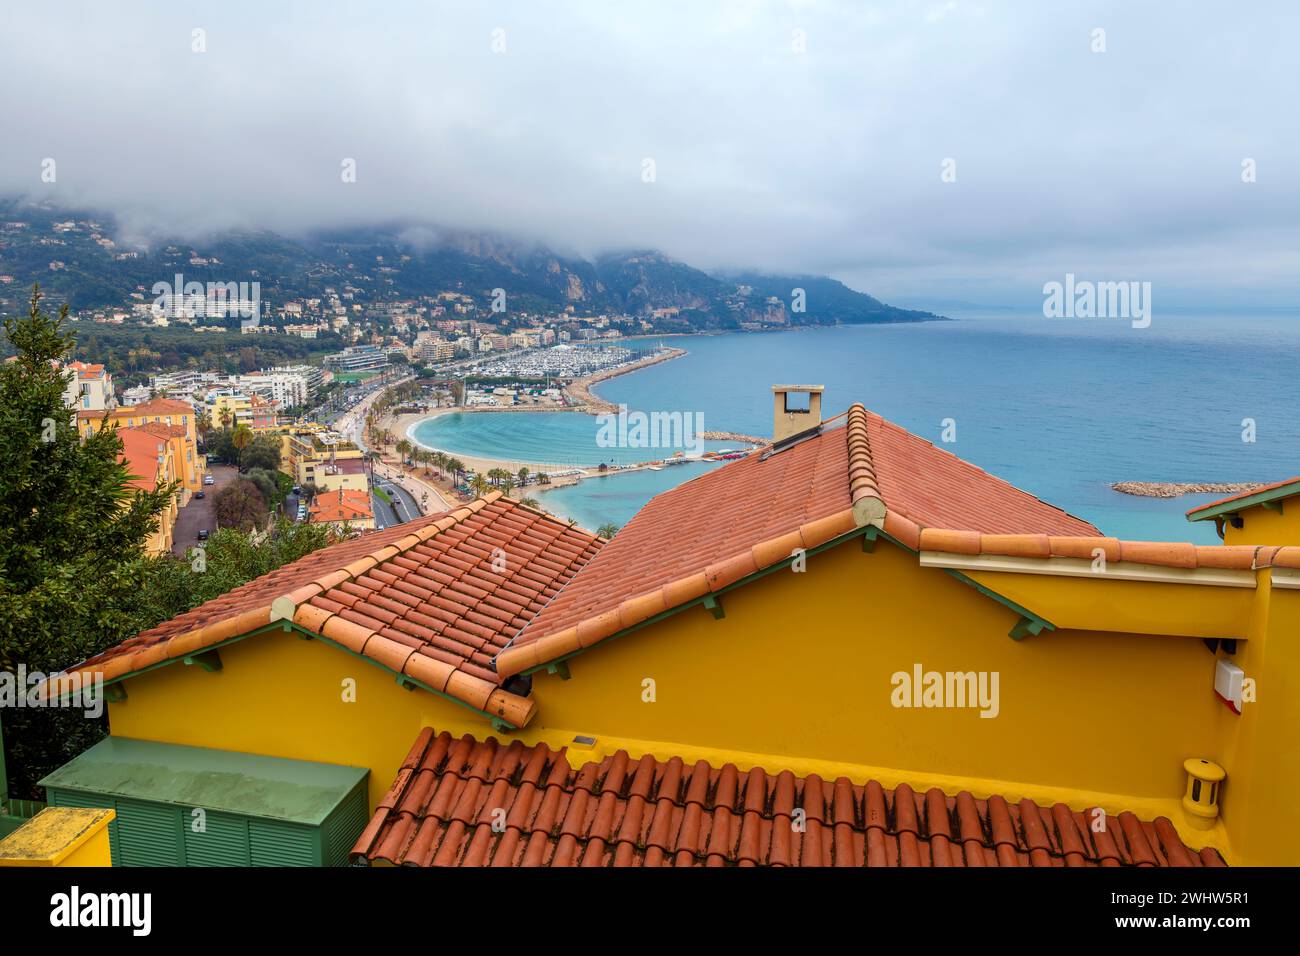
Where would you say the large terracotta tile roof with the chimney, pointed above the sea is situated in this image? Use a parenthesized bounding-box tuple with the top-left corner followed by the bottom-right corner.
(497, 405, 1100, 674)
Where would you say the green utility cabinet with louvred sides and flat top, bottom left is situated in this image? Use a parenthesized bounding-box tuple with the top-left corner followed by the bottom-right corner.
(40, 737, 369, 866)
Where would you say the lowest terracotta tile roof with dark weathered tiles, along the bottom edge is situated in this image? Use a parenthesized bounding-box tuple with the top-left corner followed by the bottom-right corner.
(352, 727, 1225, 866)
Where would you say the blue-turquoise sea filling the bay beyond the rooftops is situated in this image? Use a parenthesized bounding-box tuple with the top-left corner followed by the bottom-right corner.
(413, 311, 1300, 544)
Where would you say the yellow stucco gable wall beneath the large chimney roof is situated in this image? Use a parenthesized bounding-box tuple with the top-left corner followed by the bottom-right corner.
(534, 544, 1216, 799)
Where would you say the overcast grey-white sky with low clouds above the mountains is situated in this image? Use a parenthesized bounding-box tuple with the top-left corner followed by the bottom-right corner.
(0, 0, 1300, 304)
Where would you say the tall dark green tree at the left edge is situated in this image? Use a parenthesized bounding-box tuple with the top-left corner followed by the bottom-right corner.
(0, 287, 176, 799)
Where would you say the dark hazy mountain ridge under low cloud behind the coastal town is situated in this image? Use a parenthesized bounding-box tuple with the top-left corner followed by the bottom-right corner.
(0, 199, 944, 332)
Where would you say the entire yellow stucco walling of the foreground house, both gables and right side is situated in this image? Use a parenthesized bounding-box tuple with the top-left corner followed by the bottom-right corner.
(96, 541, 1300, 864)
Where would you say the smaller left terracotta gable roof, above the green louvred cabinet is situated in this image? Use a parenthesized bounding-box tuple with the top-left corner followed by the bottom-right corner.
(63, 492, 601, 727)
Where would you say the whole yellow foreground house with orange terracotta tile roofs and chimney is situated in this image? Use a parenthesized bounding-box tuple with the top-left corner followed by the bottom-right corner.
(35, 386, 1300, 866)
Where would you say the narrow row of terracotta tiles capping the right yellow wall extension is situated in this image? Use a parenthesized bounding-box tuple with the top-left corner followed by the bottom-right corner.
(919, 528, 1274, 571)
